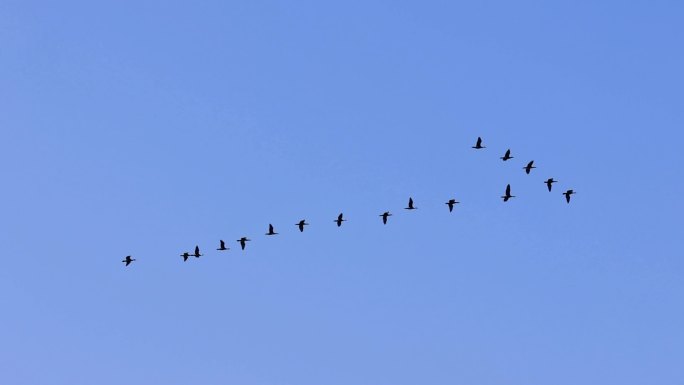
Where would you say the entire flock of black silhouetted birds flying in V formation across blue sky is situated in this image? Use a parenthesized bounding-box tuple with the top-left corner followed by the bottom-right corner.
(121, 137, 576, 266)
